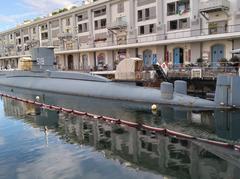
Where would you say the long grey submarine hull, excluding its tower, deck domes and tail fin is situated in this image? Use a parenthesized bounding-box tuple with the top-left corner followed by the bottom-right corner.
(0, 71, 217, 108)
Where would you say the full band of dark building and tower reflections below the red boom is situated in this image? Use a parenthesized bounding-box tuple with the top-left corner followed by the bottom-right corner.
(3, 98, 240, 179)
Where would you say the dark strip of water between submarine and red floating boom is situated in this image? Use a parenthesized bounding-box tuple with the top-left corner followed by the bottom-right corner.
(1, 87, 240, 141)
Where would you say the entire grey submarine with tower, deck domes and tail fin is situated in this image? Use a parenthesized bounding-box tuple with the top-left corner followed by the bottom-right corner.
(0, 47, 240, 109)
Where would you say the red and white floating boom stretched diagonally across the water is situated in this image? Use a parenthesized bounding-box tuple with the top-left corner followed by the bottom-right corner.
(0, 93, 240, 152)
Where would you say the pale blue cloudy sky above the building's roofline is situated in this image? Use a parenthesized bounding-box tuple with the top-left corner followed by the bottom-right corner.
(0, 0, 82, 32)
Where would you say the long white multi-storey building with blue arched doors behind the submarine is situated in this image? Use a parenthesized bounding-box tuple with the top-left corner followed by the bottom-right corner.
(0, 0, 240, 70)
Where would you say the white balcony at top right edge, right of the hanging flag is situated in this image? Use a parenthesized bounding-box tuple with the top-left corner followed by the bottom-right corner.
(199, 0, 230, 13)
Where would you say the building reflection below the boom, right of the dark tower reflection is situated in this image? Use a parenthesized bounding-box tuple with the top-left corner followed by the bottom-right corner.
(59, 113, 240, 179)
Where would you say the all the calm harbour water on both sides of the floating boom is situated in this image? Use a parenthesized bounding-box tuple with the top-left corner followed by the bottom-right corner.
(0, 89, 240, 179)
